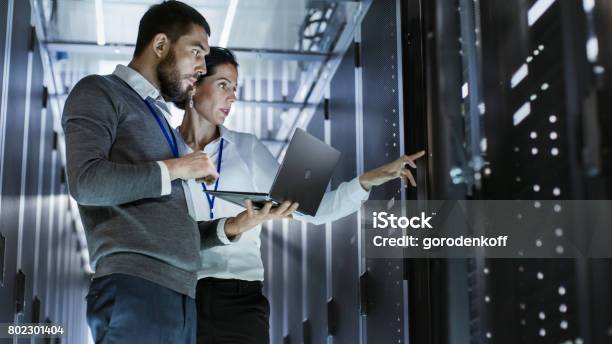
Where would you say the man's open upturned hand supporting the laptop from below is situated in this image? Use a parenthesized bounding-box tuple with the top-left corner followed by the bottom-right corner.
(225, 199, 299, 240)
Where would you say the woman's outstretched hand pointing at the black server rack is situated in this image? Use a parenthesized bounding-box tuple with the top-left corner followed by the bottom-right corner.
(359, 151, 425, 191)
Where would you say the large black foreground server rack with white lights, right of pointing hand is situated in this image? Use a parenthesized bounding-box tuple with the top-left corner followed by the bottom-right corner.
(402, 0, 611, 343)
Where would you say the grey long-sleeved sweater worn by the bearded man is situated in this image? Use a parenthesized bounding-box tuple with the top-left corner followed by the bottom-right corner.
(62, 75, 222, 297)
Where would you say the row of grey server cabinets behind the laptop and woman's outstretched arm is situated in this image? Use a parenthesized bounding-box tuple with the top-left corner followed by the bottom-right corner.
(263, 0, 408, 343)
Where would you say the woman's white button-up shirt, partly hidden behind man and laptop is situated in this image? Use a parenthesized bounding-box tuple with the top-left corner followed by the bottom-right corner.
(177, 126, 369, 281)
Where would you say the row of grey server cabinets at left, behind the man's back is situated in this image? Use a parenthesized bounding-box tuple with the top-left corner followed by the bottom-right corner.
(0, 0, 88, 343)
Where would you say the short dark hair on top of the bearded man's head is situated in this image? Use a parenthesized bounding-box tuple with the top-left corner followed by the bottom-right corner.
(134, 1, 210, 56)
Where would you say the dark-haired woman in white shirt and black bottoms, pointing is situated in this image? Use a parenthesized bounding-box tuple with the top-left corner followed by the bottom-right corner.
(177, 47, 424, 344)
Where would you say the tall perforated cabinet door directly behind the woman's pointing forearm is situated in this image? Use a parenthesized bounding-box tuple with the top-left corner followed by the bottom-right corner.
(361, 0, 407, 343)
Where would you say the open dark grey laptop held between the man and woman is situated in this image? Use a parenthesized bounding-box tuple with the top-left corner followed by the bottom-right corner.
(205, 128, 340, 216)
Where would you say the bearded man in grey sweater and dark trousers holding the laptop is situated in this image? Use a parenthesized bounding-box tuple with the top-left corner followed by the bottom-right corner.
(62, 1, 295, 343)
